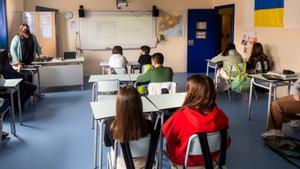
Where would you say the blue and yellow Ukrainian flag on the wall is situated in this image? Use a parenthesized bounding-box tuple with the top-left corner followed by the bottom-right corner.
(254, 0, 284, 27)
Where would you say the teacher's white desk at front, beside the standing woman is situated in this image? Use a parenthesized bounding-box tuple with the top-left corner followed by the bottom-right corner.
(32, 57, 84, 89)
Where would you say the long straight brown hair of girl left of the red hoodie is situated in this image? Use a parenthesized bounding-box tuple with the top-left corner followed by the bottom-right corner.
(111, 86, 145, 142)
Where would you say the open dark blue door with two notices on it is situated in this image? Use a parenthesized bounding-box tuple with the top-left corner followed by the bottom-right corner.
(187, 9, 220, 73)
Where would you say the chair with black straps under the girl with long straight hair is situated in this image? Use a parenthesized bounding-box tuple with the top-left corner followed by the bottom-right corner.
(108, 116, 161, 169)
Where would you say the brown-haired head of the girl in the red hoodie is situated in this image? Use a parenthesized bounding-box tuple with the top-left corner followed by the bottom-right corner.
(183, 75, 216, 113)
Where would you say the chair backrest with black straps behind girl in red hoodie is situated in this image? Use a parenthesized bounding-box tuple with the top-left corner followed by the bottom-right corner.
(184, 129, 228, 169)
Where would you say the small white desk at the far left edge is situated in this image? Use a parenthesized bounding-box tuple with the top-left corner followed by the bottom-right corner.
(0, 79, 23, 129)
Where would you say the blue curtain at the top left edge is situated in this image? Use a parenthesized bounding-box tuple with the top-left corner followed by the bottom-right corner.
(0, 0, 8, 49)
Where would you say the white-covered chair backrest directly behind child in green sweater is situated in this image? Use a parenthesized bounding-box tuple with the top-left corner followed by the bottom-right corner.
(148, 82, 177, 95)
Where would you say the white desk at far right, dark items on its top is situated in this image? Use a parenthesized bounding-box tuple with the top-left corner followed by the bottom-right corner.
(248, 74, 300, 128)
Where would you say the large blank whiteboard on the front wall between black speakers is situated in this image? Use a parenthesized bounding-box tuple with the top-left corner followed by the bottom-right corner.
(80, 11, 156, 50)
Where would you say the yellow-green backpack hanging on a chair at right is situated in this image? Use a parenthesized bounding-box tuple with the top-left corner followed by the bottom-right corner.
(229, 63, 250, 93)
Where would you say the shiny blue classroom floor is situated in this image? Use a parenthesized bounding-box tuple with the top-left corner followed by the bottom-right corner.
(0, 74, 300, 169)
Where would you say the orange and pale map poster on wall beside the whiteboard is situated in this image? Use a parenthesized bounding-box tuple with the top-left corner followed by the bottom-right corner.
(157, 13, 184, 38)
